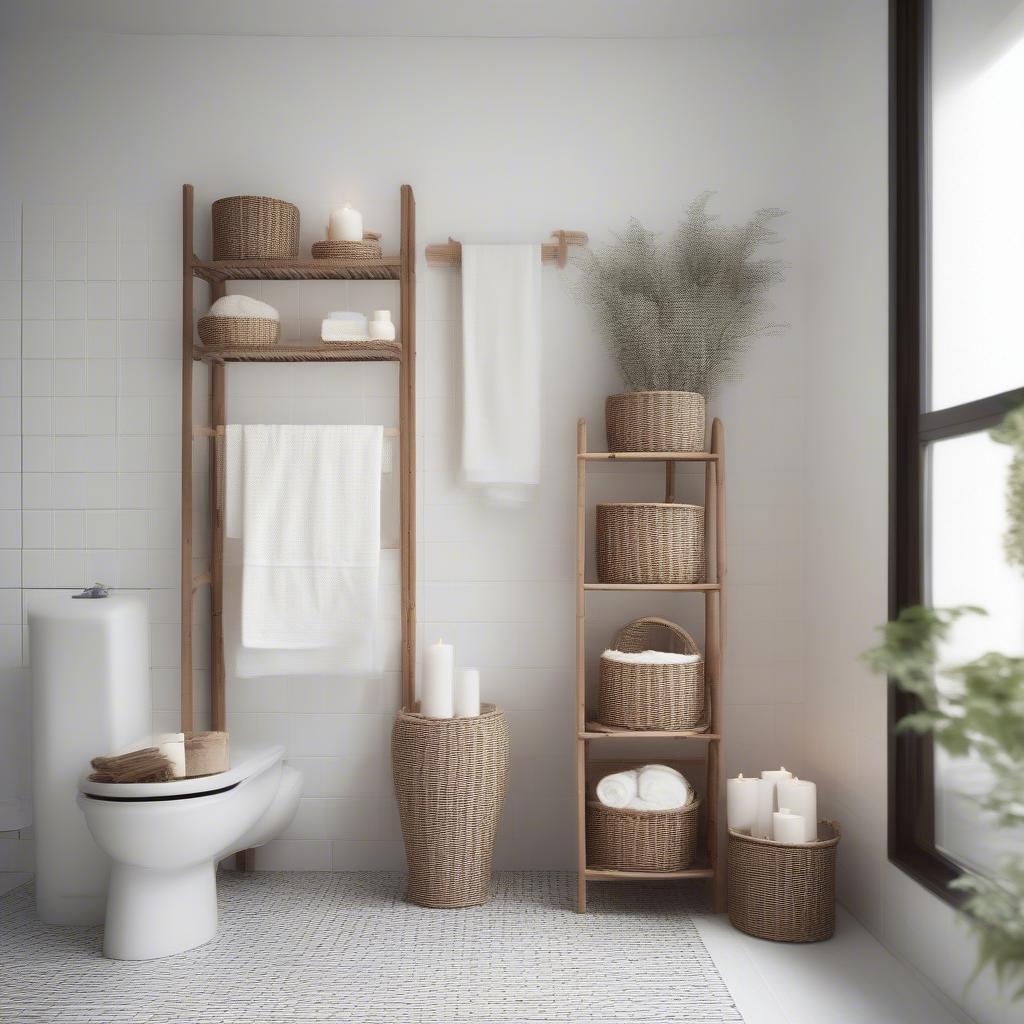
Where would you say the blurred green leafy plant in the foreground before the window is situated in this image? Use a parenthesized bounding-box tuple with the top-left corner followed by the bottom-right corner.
(864, 408, 1024, 999)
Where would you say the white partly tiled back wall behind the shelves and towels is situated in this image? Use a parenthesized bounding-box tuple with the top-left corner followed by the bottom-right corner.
(0, 24, 817, 868)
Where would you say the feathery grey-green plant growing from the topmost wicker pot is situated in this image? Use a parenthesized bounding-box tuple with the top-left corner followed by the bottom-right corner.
(577, 191, 784, 398)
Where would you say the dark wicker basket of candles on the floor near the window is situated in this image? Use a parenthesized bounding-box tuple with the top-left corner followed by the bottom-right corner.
(728, 821, 840, 942)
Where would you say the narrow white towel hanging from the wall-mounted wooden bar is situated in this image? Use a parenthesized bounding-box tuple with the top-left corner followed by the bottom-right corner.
(462, 245, 541, 505)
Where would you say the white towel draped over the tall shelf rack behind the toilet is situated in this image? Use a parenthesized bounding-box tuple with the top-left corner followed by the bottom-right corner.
(225, 426, 383, 649)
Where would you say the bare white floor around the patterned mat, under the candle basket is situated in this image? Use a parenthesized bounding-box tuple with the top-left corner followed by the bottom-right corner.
(0, 872, 967, 1024)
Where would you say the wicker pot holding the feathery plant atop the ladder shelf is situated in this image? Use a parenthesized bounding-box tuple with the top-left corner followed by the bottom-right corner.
(604, 391, 706, 452)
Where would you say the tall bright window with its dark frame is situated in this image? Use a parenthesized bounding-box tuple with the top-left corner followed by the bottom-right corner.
(889, 0, 1024, 898)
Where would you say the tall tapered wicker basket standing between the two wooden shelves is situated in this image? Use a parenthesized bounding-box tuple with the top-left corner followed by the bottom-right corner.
(391, 705, 509, 907)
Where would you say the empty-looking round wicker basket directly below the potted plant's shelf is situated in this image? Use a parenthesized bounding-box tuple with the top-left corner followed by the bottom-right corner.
(597, 502, 707, 584)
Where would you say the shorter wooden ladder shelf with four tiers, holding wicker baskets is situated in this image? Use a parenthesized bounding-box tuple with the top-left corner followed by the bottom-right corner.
(575, 419, 726, 913)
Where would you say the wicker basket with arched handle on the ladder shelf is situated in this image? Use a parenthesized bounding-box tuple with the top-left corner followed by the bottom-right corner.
(598, 615, 705, 729)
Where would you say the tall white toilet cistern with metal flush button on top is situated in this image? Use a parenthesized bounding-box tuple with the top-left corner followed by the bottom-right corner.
(29, 592, 153, 925)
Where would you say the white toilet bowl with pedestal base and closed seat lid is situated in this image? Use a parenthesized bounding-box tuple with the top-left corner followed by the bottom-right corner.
(78, 746, 302, 959)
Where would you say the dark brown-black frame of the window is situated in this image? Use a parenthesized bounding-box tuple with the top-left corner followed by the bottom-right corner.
(888, 0, 1024, 905)
